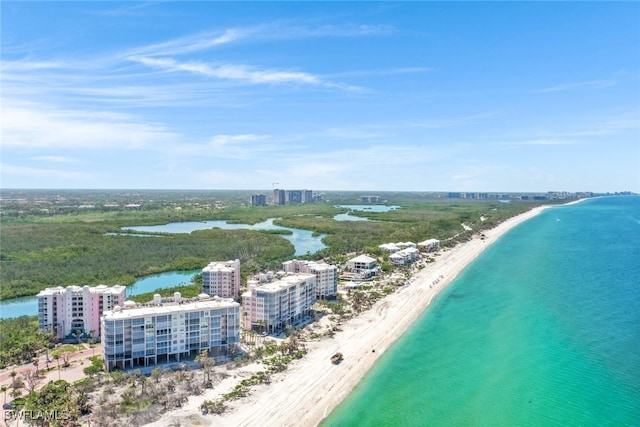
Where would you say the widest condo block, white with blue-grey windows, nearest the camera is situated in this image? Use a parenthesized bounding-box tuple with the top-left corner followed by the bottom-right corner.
(101, 292, 240, 371)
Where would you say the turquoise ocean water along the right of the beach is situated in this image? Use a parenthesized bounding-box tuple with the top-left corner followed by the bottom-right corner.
(323, 196, 640, 426)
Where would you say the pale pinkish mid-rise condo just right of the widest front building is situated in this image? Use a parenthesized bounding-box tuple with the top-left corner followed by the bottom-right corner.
(242, 273, 316, 333)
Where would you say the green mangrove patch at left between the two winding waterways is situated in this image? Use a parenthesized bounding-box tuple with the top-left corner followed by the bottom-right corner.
(0, 224, 294, 299)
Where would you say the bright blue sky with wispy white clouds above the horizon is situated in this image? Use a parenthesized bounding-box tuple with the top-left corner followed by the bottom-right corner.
(0, 1, 640, 192)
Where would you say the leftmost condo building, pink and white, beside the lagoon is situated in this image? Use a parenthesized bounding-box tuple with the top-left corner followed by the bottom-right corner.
(37, 285, 127, 338)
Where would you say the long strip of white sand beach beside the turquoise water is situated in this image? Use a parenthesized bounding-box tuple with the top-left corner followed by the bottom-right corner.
(147, 199, 564, 427)
